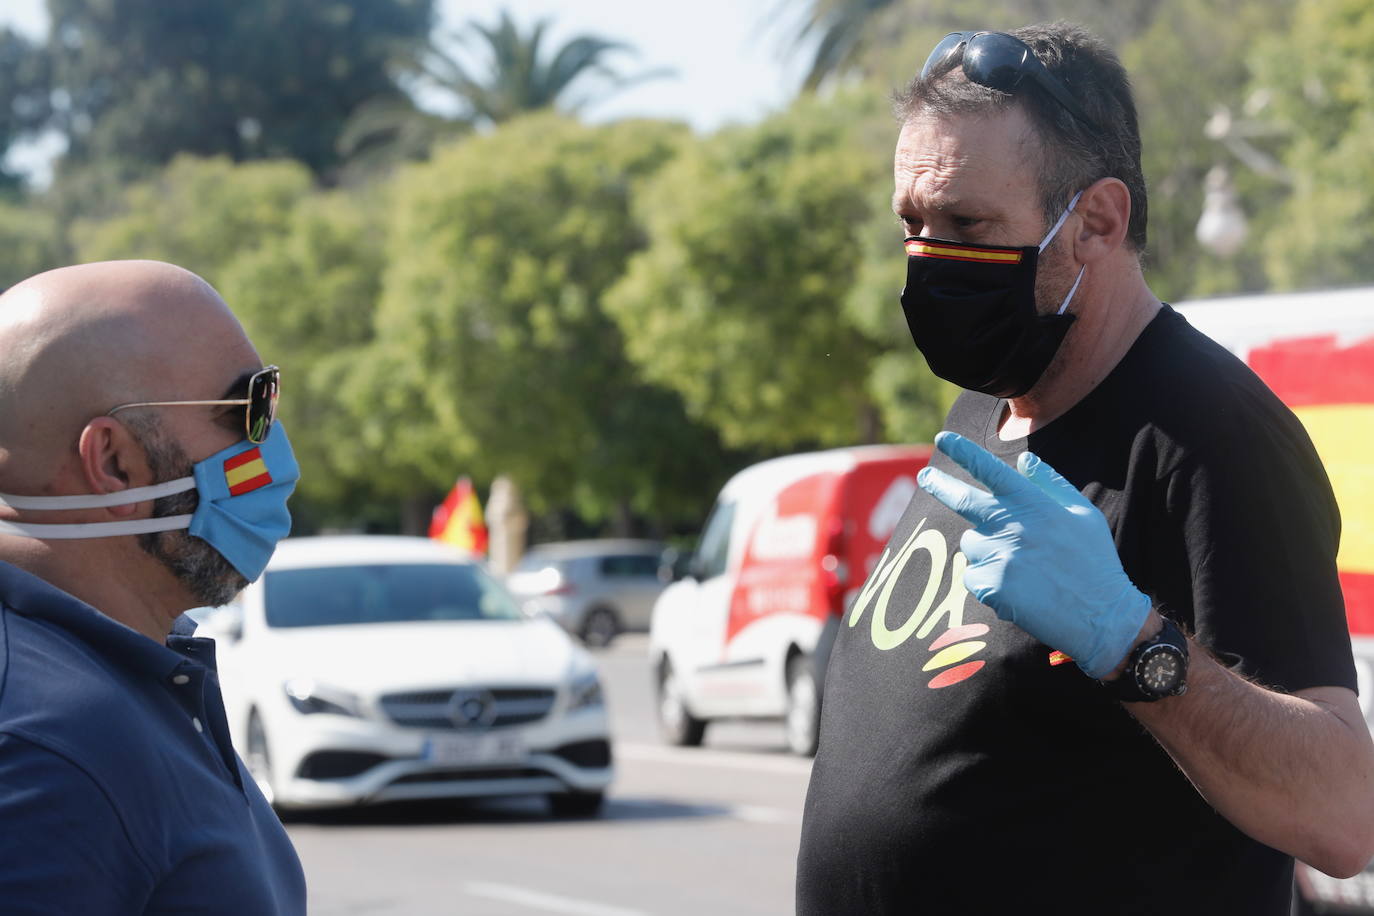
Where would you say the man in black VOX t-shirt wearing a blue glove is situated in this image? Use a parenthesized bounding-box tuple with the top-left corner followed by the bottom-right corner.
(797, 25, 1374, 916)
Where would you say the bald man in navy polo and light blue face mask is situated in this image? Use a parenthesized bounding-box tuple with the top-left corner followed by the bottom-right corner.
(0, 261, 305, 916)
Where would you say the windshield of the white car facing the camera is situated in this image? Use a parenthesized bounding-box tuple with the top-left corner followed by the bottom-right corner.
(264, 563, 521, 628)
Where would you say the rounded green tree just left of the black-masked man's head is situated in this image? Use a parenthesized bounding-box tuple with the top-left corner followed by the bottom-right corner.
(607, 98, 894, 450)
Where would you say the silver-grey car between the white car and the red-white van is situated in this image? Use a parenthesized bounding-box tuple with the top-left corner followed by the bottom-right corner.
(506, 540, 666, 647)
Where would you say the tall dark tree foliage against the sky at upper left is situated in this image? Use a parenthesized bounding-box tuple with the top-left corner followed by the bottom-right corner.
(48, 0, 433, 173)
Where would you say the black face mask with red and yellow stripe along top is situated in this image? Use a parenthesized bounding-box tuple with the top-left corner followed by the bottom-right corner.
(901, 196, 1083, 398)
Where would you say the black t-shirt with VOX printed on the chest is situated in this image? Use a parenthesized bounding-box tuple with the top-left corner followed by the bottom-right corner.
(797, 306, 1356, 916)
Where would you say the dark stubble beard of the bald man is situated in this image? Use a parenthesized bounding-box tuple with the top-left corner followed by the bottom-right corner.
(136, 424, 249, 607)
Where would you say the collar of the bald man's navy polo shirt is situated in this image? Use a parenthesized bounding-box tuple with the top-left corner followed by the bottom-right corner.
(0, 562, 214, 678)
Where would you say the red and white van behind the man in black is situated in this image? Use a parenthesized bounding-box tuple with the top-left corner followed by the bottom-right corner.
(649, 445, 930, 755)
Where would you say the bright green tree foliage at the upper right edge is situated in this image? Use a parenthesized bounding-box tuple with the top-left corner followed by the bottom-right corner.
(1250, 0, 1374, 288)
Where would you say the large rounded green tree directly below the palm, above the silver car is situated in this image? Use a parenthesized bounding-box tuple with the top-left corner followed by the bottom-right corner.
(362, 115, 723, 519)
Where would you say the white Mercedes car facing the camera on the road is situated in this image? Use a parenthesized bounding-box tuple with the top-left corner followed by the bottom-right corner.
(198, 537, 613, 816)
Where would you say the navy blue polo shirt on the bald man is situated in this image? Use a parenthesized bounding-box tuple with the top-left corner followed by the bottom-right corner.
(0, 563, 305, 916)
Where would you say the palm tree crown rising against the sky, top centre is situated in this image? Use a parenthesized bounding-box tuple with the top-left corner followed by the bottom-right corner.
(425, 10, 668, 124)
